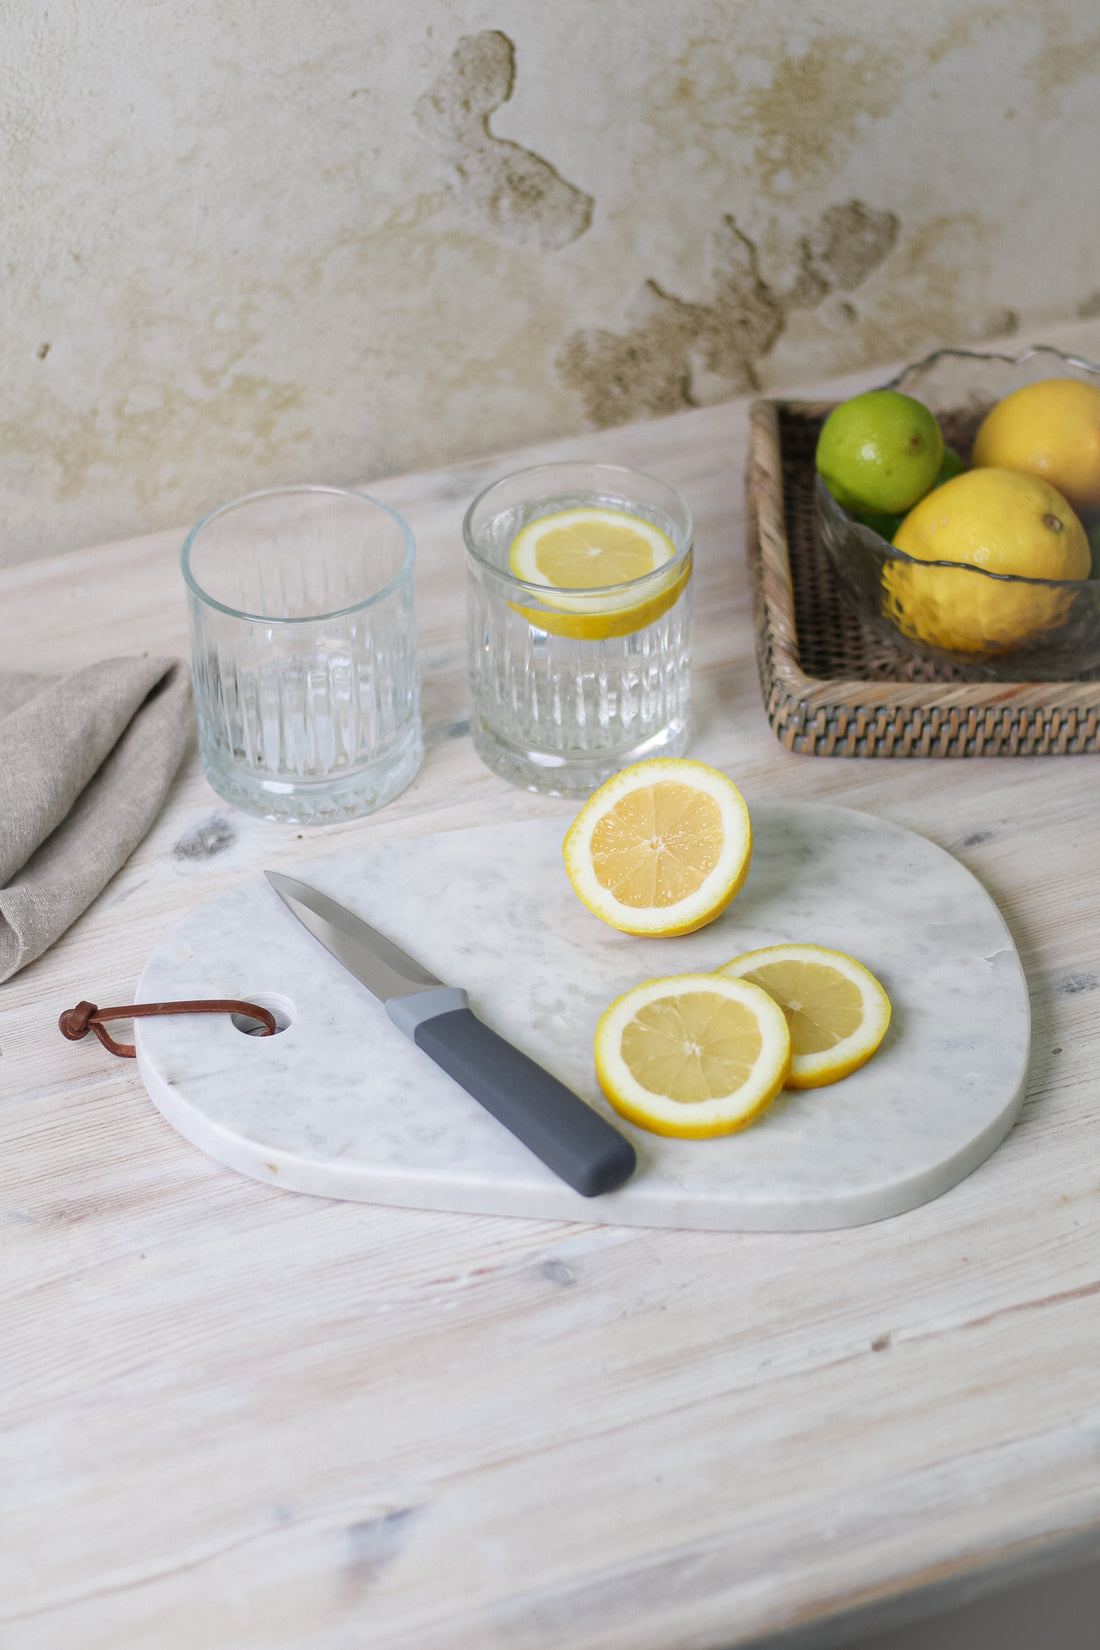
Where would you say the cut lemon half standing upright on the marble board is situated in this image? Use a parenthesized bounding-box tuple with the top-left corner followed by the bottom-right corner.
(562, 757, 752, 934)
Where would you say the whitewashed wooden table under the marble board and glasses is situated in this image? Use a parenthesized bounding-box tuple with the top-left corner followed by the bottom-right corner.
(0, 323, 1100, 1650)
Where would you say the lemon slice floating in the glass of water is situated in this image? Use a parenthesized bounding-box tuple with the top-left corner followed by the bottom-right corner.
(508, 505, 691, 640)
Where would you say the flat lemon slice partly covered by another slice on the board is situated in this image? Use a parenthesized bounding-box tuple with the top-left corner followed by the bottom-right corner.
(717, 945, 891, 1089)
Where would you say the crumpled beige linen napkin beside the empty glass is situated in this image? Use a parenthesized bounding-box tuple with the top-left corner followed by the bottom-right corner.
(0, 658, 193, 980)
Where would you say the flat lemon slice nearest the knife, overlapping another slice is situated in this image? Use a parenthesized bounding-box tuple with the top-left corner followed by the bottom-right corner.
(595, 974, 790, 1140)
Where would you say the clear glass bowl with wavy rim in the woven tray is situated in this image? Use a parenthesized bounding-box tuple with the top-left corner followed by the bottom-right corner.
(815, 345, 1100, 681)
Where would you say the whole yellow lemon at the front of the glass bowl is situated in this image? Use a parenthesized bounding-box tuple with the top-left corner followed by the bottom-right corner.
(882, 469, 1092, 655)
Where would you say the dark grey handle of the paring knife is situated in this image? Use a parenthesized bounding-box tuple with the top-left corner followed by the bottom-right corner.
(412, 1008, 635, 1198)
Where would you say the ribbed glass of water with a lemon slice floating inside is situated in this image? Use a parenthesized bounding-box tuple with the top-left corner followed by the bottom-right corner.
(463, 464, 693, 797)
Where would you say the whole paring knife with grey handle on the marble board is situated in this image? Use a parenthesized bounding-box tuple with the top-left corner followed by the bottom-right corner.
(264, 871, 635, 1198)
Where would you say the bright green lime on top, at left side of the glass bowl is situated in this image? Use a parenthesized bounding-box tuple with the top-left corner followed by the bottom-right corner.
(815, 389, 943, 515)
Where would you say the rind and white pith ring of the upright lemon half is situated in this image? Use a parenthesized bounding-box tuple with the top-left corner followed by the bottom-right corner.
(562, 756, 752, 939)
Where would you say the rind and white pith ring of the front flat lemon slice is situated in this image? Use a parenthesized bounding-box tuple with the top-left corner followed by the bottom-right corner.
(595, 974, 790, 1140)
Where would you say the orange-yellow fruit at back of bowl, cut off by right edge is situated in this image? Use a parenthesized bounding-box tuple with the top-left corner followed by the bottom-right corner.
(973, 378, 1100, 510)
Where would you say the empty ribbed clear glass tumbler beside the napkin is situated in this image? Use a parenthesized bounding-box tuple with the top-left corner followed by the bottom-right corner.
(183, 487, 422, 825)
